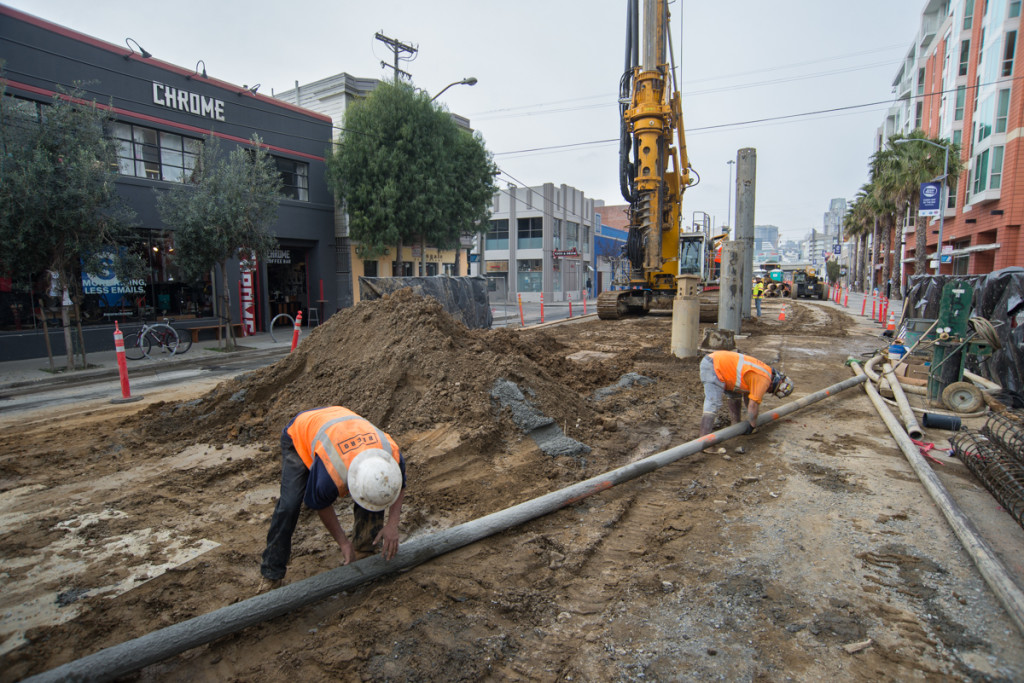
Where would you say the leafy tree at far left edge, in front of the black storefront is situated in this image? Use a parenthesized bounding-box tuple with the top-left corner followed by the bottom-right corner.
(0, 81, 143, 370)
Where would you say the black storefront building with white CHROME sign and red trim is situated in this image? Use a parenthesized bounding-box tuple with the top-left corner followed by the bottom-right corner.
(0, 5, 335, 360)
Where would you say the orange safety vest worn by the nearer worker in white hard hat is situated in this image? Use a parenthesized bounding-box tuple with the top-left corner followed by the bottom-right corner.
(286, 407, 401, 496)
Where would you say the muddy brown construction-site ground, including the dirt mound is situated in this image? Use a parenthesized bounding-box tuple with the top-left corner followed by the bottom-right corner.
(0, 292, 1024, 681)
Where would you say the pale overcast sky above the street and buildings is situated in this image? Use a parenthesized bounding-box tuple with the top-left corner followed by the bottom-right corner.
(8, 0, 925, 239)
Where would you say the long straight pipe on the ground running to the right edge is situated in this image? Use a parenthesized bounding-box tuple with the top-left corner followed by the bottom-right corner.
(850, 366, 1024, 634)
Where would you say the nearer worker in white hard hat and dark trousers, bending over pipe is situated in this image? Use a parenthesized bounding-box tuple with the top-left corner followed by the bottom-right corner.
(260, 405, 406, 588)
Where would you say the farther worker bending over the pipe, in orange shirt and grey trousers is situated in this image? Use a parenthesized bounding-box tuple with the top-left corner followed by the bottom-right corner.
(700, 351, 793, 436)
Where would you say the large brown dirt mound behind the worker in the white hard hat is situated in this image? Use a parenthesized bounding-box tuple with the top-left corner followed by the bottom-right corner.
(133, 290, 606, 454)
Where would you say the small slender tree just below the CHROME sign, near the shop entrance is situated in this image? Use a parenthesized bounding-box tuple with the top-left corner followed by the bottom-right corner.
(155, 134, 282, 349)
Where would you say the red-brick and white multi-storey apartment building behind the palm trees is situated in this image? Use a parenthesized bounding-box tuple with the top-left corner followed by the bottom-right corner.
(876, 0, 1024, 282)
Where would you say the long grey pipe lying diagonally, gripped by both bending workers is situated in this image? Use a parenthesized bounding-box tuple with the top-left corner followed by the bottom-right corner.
(27, 375, 866, 683)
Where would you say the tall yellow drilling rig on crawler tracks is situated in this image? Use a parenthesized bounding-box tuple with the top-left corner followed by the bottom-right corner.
(597, 0, 700, 319)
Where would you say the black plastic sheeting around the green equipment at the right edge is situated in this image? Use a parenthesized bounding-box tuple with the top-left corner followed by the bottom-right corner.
(903, 266, 1024, 396)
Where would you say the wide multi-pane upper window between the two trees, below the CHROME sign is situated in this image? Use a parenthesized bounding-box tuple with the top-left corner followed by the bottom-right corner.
(111, 122, 203, 182)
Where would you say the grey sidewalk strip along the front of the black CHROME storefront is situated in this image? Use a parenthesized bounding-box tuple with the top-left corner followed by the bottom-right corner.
(0, 328, 292, 394)
